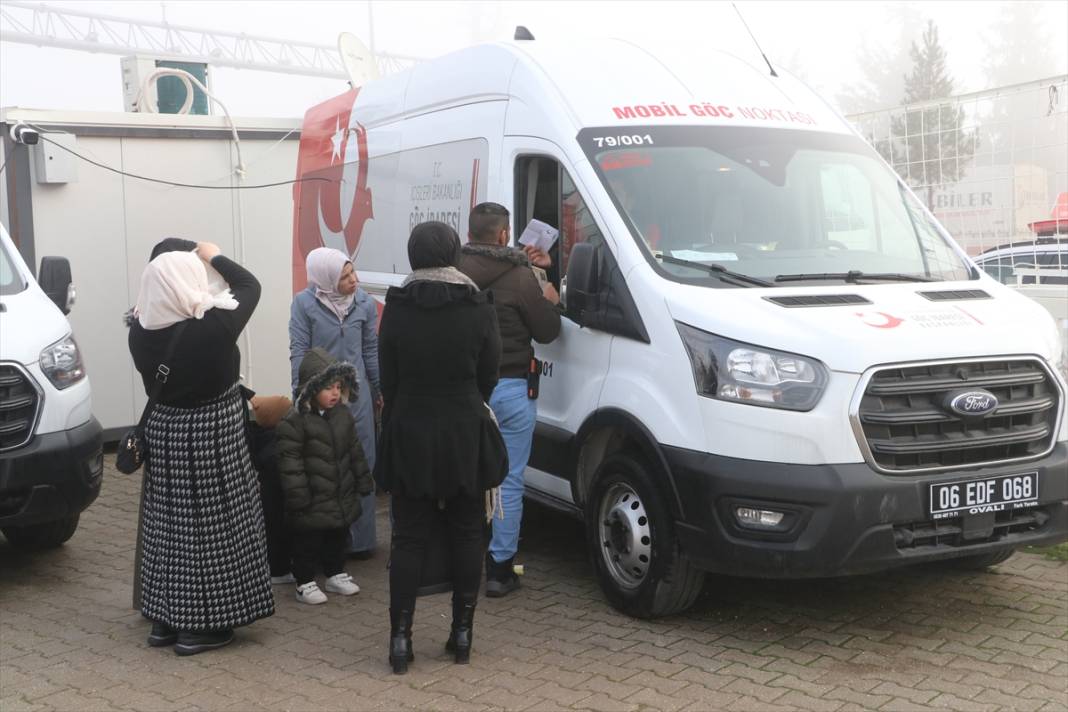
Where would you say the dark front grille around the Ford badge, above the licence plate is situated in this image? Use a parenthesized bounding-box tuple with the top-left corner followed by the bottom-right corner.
(854, 359, 1062, 474)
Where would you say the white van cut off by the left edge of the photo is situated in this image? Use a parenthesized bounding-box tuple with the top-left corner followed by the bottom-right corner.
(0, 225, 104, 549)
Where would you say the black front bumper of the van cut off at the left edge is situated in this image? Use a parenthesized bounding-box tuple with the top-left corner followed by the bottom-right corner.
(0, 417, 104, 526)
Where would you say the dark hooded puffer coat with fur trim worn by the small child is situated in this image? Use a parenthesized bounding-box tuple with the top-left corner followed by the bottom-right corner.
(276, 349, 374, 531)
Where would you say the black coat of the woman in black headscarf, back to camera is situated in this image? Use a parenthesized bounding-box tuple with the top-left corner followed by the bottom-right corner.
(375, 281, 508, 499)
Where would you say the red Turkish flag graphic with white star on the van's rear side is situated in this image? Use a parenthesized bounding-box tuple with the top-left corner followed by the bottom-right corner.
(293, 90, 374, 292)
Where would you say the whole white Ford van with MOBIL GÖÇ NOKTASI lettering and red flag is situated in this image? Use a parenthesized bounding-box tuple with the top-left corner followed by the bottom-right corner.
(294, 41, 1068, 616)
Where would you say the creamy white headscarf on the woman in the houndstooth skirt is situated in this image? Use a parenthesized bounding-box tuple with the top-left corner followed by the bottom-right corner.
(135, 252, 237, 331)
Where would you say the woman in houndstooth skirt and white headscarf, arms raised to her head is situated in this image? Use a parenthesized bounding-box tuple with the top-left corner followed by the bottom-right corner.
(129, 242, 274, 655)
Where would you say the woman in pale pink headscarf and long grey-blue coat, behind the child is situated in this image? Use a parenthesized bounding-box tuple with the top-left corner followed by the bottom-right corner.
(289, 248, 381, 557)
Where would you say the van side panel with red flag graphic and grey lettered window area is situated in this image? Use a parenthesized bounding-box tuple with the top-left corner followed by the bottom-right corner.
(293, 94, 505, 283)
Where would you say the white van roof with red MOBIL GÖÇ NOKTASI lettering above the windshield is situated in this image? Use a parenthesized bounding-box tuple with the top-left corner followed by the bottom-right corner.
(380, 39, 851, 132)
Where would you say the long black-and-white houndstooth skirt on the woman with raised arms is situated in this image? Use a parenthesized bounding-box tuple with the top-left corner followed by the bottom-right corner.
(141, 384, 274, 631)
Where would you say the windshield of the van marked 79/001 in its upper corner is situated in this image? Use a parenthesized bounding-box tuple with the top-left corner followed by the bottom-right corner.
(579, 126, 977, 286)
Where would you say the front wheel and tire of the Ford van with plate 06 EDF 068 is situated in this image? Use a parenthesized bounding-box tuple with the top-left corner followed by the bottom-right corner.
(585, 455, 705, 618)
